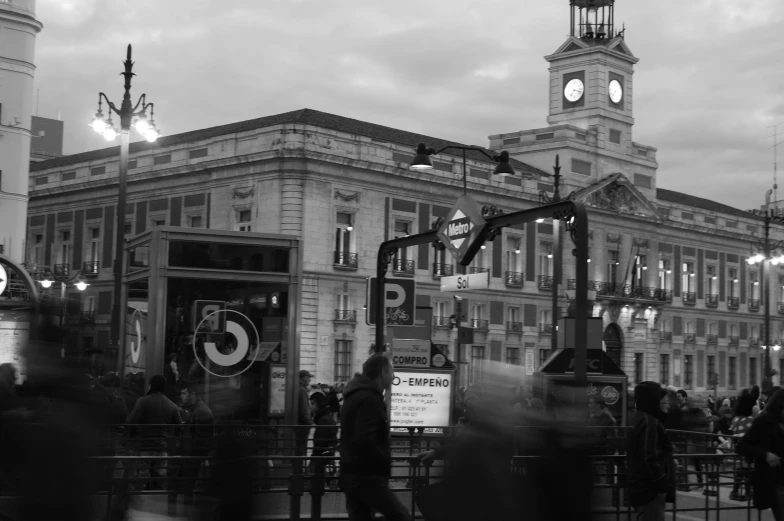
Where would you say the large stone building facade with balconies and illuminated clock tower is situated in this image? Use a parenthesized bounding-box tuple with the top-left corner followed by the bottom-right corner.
(26, 2, 784, 393)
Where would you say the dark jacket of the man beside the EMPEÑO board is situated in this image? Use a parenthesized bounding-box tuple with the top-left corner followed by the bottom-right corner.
(340, 376, 392, 478)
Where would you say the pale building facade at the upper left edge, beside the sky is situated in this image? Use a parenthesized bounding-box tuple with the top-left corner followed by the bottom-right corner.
(0, 0, 43, 262)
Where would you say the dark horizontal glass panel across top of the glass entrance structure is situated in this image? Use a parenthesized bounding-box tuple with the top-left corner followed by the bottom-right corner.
(169, 241, 289, 273)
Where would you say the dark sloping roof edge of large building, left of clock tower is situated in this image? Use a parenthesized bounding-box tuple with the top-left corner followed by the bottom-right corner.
(30, 109, 552, 177)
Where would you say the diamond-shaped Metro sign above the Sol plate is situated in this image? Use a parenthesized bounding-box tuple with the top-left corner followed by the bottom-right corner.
(437, 195, 487, 266)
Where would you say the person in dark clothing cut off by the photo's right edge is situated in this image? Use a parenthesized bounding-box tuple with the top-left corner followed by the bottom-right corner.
(737, 390, 784, 521)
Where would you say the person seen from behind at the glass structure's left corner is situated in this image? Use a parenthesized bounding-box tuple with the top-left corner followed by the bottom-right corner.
(125, 374, 182, 489)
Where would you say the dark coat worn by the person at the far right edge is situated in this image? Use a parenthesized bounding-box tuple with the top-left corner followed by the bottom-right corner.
(736, 402, 784, 510)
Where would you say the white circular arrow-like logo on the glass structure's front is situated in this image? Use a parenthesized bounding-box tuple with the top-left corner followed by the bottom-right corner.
(193, 309, 259, 378)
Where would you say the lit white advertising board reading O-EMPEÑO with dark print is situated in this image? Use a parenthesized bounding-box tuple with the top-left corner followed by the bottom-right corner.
(390, 370, 454, 433)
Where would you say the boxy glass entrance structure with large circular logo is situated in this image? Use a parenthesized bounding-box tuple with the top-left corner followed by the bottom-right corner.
(120, 226, 302, 421)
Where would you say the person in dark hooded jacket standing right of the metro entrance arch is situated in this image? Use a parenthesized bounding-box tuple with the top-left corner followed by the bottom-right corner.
(626, 382, 675, 521)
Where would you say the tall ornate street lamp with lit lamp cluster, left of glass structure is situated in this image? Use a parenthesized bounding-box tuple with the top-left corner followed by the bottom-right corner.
(92, 44, 160, 374)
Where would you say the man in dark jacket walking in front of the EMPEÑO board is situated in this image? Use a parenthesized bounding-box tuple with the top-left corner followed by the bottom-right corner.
(340, 354, 411, 521)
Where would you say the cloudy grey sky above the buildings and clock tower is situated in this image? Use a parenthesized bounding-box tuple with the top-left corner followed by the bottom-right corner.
(36, 0, 784, 209)
